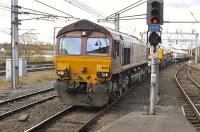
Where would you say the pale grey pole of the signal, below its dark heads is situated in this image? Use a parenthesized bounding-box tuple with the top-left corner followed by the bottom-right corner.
(149, 46, 157, 115)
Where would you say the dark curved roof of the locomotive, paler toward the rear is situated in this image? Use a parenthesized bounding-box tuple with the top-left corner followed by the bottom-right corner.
(57, 19, 140, 42)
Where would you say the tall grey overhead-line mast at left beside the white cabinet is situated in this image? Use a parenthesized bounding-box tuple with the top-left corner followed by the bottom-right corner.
(11, 0, 19, 89)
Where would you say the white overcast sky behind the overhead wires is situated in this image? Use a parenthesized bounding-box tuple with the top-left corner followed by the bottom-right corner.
(0, 0, 200, 47)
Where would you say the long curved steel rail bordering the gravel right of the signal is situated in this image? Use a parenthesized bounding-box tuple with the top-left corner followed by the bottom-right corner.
(175, 66, 200, 120)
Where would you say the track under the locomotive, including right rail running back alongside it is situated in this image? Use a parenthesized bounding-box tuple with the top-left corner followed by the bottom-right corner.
(25, 77, 147, 132)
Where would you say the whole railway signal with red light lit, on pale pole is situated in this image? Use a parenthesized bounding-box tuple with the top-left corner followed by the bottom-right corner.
(147, 0, 163, 115)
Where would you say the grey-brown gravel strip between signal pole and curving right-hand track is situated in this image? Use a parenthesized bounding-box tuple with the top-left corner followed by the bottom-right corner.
(159, 65, 183, 110)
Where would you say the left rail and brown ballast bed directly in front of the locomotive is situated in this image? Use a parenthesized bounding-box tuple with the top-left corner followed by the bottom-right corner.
(25, 106, 101, 132)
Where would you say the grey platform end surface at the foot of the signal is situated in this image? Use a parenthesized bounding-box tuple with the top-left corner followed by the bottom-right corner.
(98, 111, 196, 132)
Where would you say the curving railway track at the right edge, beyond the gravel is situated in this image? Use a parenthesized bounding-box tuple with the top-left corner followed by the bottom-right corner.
(175, 65, 200, 131)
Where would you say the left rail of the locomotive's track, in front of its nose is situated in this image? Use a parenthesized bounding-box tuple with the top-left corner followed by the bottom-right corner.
(24, 105, 77, 132)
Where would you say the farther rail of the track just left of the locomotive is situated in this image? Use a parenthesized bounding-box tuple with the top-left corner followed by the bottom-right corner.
(0, 88, 54, 106)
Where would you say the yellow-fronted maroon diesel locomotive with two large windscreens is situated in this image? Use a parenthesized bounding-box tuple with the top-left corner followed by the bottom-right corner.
(54, 20, 149, 107)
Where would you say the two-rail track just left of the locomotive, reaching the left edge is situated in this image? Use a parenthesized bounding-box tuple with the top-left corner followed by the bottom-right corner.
(0, 88, 57, 120)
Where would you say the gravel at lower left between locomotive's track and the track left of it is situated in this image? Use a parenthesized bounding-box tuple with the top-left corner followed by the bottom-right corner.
(0, 98, 65, 132)
